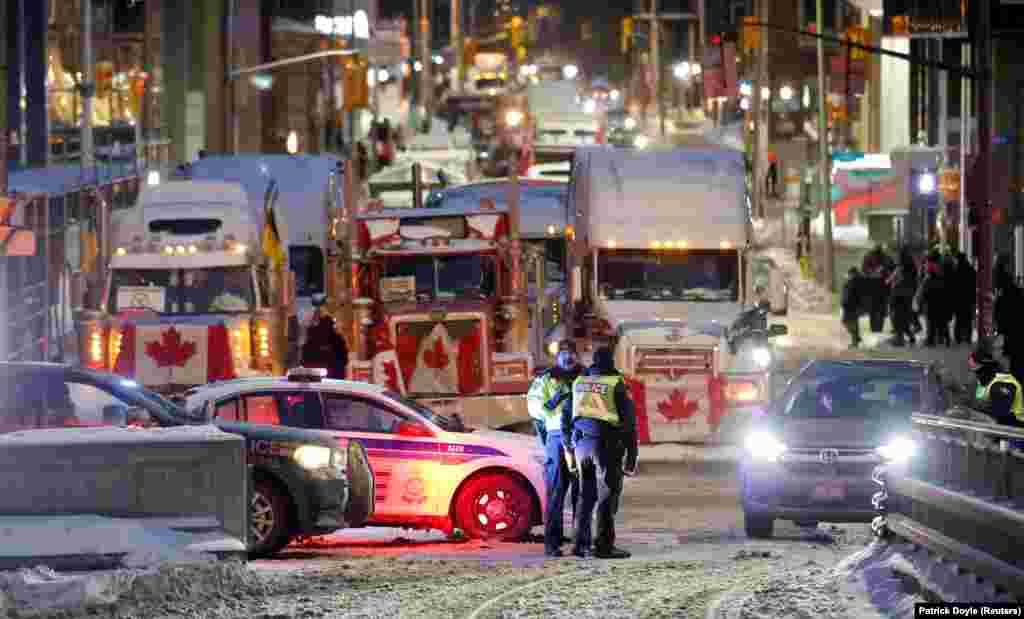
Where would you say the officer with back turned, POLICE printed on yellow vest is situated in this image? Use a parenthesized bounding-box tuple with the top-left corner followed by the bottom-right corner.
(562, 346, 638, 559)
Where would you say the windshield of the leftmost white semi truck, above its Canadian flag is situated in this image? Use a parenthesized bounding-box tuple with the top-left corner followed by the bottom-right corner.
(109, 266, 255, 316)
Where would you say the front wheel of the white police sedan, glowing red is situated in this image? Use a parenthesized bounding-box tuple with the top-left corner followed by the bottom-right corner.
(455, 473, 534, 541)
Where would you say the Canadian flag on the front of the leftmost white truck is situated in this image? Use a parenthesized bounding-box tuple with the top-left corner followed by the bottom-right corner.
(114, 323, 236, 386)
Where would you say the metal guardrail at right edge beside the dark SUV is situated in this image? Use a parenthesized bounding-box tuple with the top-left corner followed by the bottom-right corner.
(871, 415, 1024, 599)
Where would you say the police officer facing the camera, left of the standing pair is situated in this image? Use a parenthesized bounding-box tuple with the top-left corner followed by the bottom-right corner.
(526, 340, 582, 556)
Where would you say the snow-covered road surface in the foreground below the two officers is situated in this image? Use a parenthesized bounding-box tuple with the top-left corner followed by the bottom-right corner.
(8, 463, 925, 619)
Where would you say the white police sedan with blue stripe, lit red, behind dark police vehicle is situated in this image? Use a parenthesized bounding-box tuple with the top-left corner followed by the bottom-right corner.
(185, 368, 545, 540)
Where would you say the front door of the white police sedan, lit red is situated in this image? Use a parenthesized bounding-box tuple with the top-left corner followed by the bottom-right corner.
(323, 394, 445, 524)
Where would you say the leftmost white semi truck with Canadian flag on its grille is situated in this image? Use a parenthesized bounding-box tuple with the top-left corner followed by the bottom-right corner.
(75, 176, 298, 395)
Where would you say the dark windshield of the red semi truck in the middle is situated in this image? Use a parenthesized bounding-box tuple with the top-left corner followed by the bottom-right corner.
(384, 254, 495, 299)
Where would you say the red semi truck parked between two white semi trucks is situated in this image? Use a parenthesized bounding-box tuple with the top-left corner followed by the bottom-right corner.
(343, 190, 534, 429)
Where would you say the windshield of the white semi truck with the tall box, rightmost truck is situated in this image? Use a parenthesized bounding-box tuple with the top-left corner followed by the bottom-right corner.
(597, 249, 739, 301)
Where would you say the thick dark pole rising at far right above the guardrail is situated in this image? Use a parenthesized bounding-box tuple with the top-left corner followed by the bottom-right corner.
(974, 2, 992, 337)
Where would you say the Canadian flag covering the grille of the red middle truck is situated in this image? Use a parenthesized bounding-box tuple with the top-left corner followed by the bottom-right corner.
(395, 318, 486, 397)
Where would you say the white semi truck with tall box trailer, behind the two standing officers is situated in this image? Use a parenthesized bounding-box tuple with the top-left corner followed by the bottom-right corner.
(556, 147, 786, 443)
